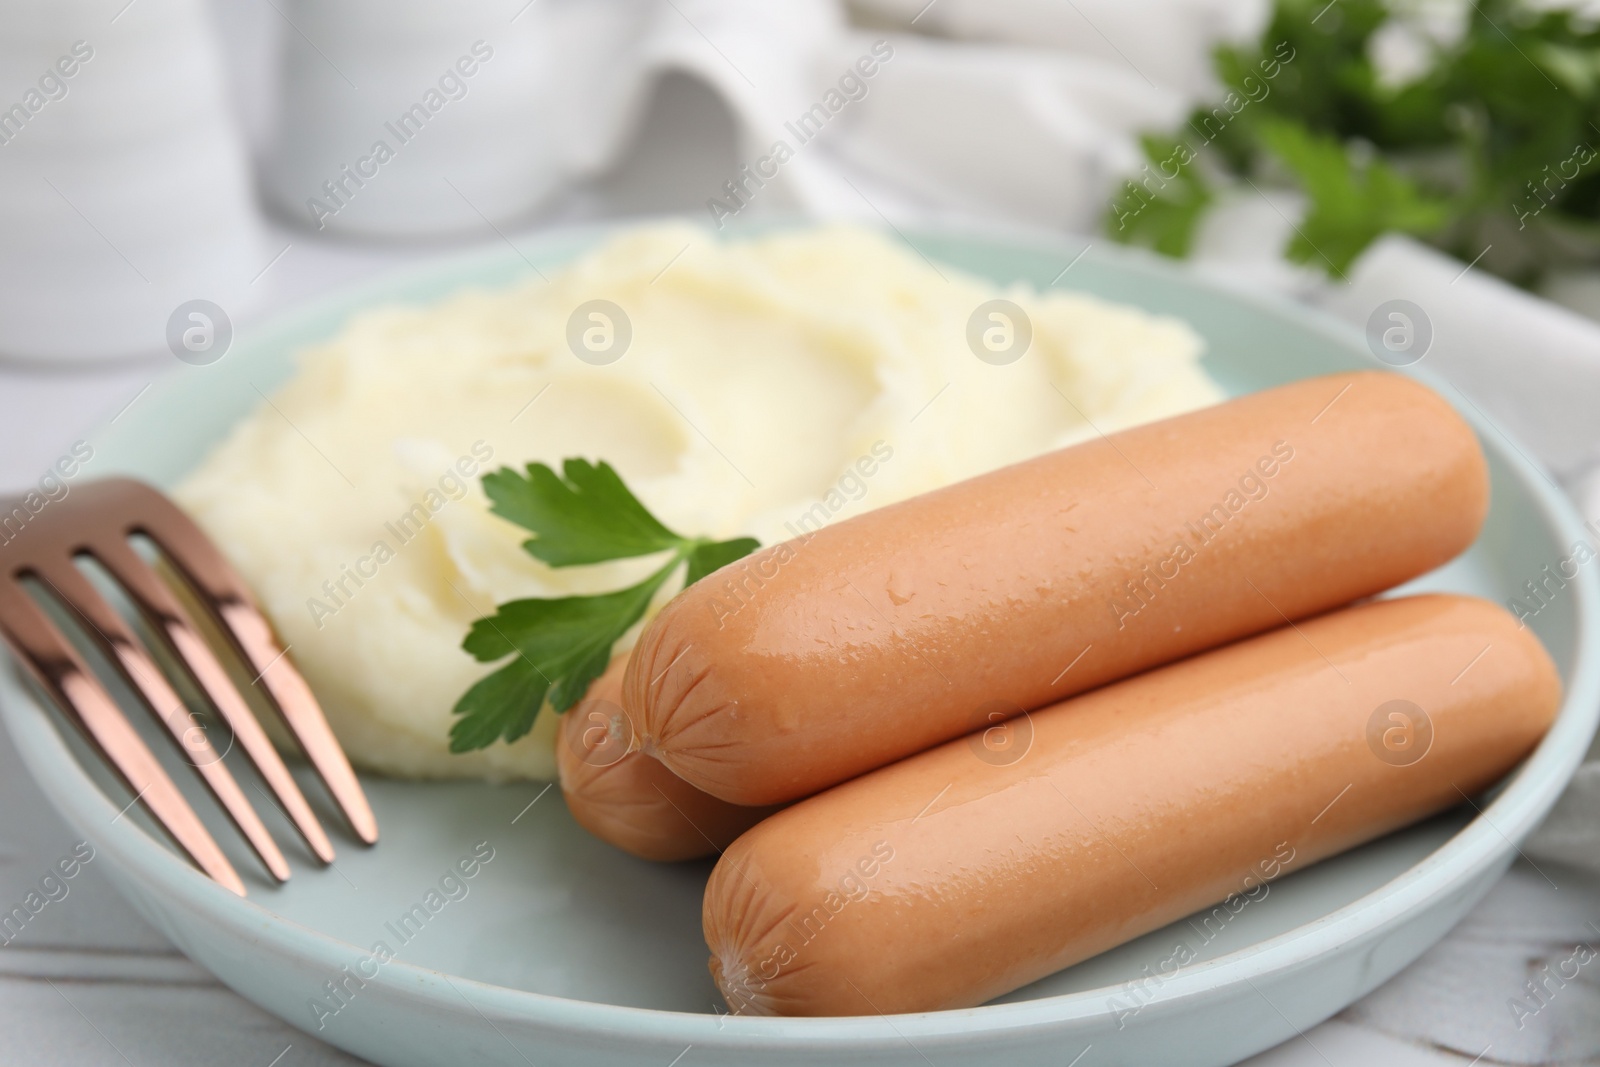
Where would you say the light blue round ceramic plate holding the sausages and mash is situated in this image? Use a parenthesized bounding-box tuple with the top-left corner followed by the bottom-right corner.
(0, 220, 1600, 1067)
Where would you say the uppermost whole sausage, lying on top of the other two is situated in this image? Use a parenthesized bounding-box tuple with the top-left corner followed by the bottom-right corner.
(622, 371, 1488, 805)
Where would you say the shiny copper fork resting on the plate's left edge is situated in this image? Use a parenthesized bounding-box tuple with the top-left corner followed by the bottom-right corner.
(0, 478, 378, 896)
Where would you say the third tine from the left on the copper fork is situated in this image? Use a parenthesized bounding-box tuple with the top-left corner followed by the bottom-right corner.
(88, 536, 333, 864)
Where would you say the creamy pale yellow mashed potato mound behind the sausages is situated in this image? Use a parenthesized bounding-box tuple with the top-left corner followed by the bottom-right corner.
(176, 224, 1221, 779)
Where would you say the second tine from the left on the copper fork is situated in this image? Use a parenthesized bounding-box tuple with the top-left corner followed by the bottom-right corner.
(34, 558, 290, 881)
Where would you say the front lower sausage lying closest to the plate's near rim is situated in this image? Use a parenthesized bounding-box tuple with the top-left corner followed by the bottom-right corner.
(704, 595, 1560, 1016)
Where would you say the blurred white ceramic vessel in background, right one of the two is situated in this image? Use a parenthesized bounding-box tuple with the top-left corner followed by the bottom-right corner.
(262, 0, 650, 237)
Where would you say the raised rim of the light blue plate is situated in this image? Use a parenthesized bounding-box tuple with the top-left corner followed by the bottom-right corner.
(0, 216, 1600, 1048)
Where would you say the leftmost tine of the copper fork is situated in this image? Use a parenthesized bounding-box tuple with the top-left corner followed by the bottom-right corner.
(0, 576, 245, 896)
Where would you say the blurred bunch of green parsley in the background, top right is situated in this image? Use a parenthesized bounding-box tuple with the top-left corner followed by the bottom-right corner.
(1107, 0, 1600, 285)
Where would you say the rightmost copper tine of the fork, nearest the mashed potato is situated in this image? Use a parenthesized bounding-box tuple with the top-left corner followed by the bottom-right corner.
(96, 480, 378, 845)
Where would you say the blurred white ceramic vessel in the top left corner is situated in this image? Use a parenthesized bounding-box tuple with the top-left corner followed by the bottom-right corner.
(0, 0, 266, 362)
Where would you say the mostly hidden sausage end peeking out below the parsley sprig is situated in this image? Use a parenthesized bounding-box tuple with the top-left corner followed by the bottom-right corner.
(555, 657, 773, 861)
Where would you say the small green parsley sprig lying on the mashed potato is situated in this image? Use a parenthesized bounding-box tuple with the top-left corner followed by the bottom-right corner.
(450, 459, 760, 752)
